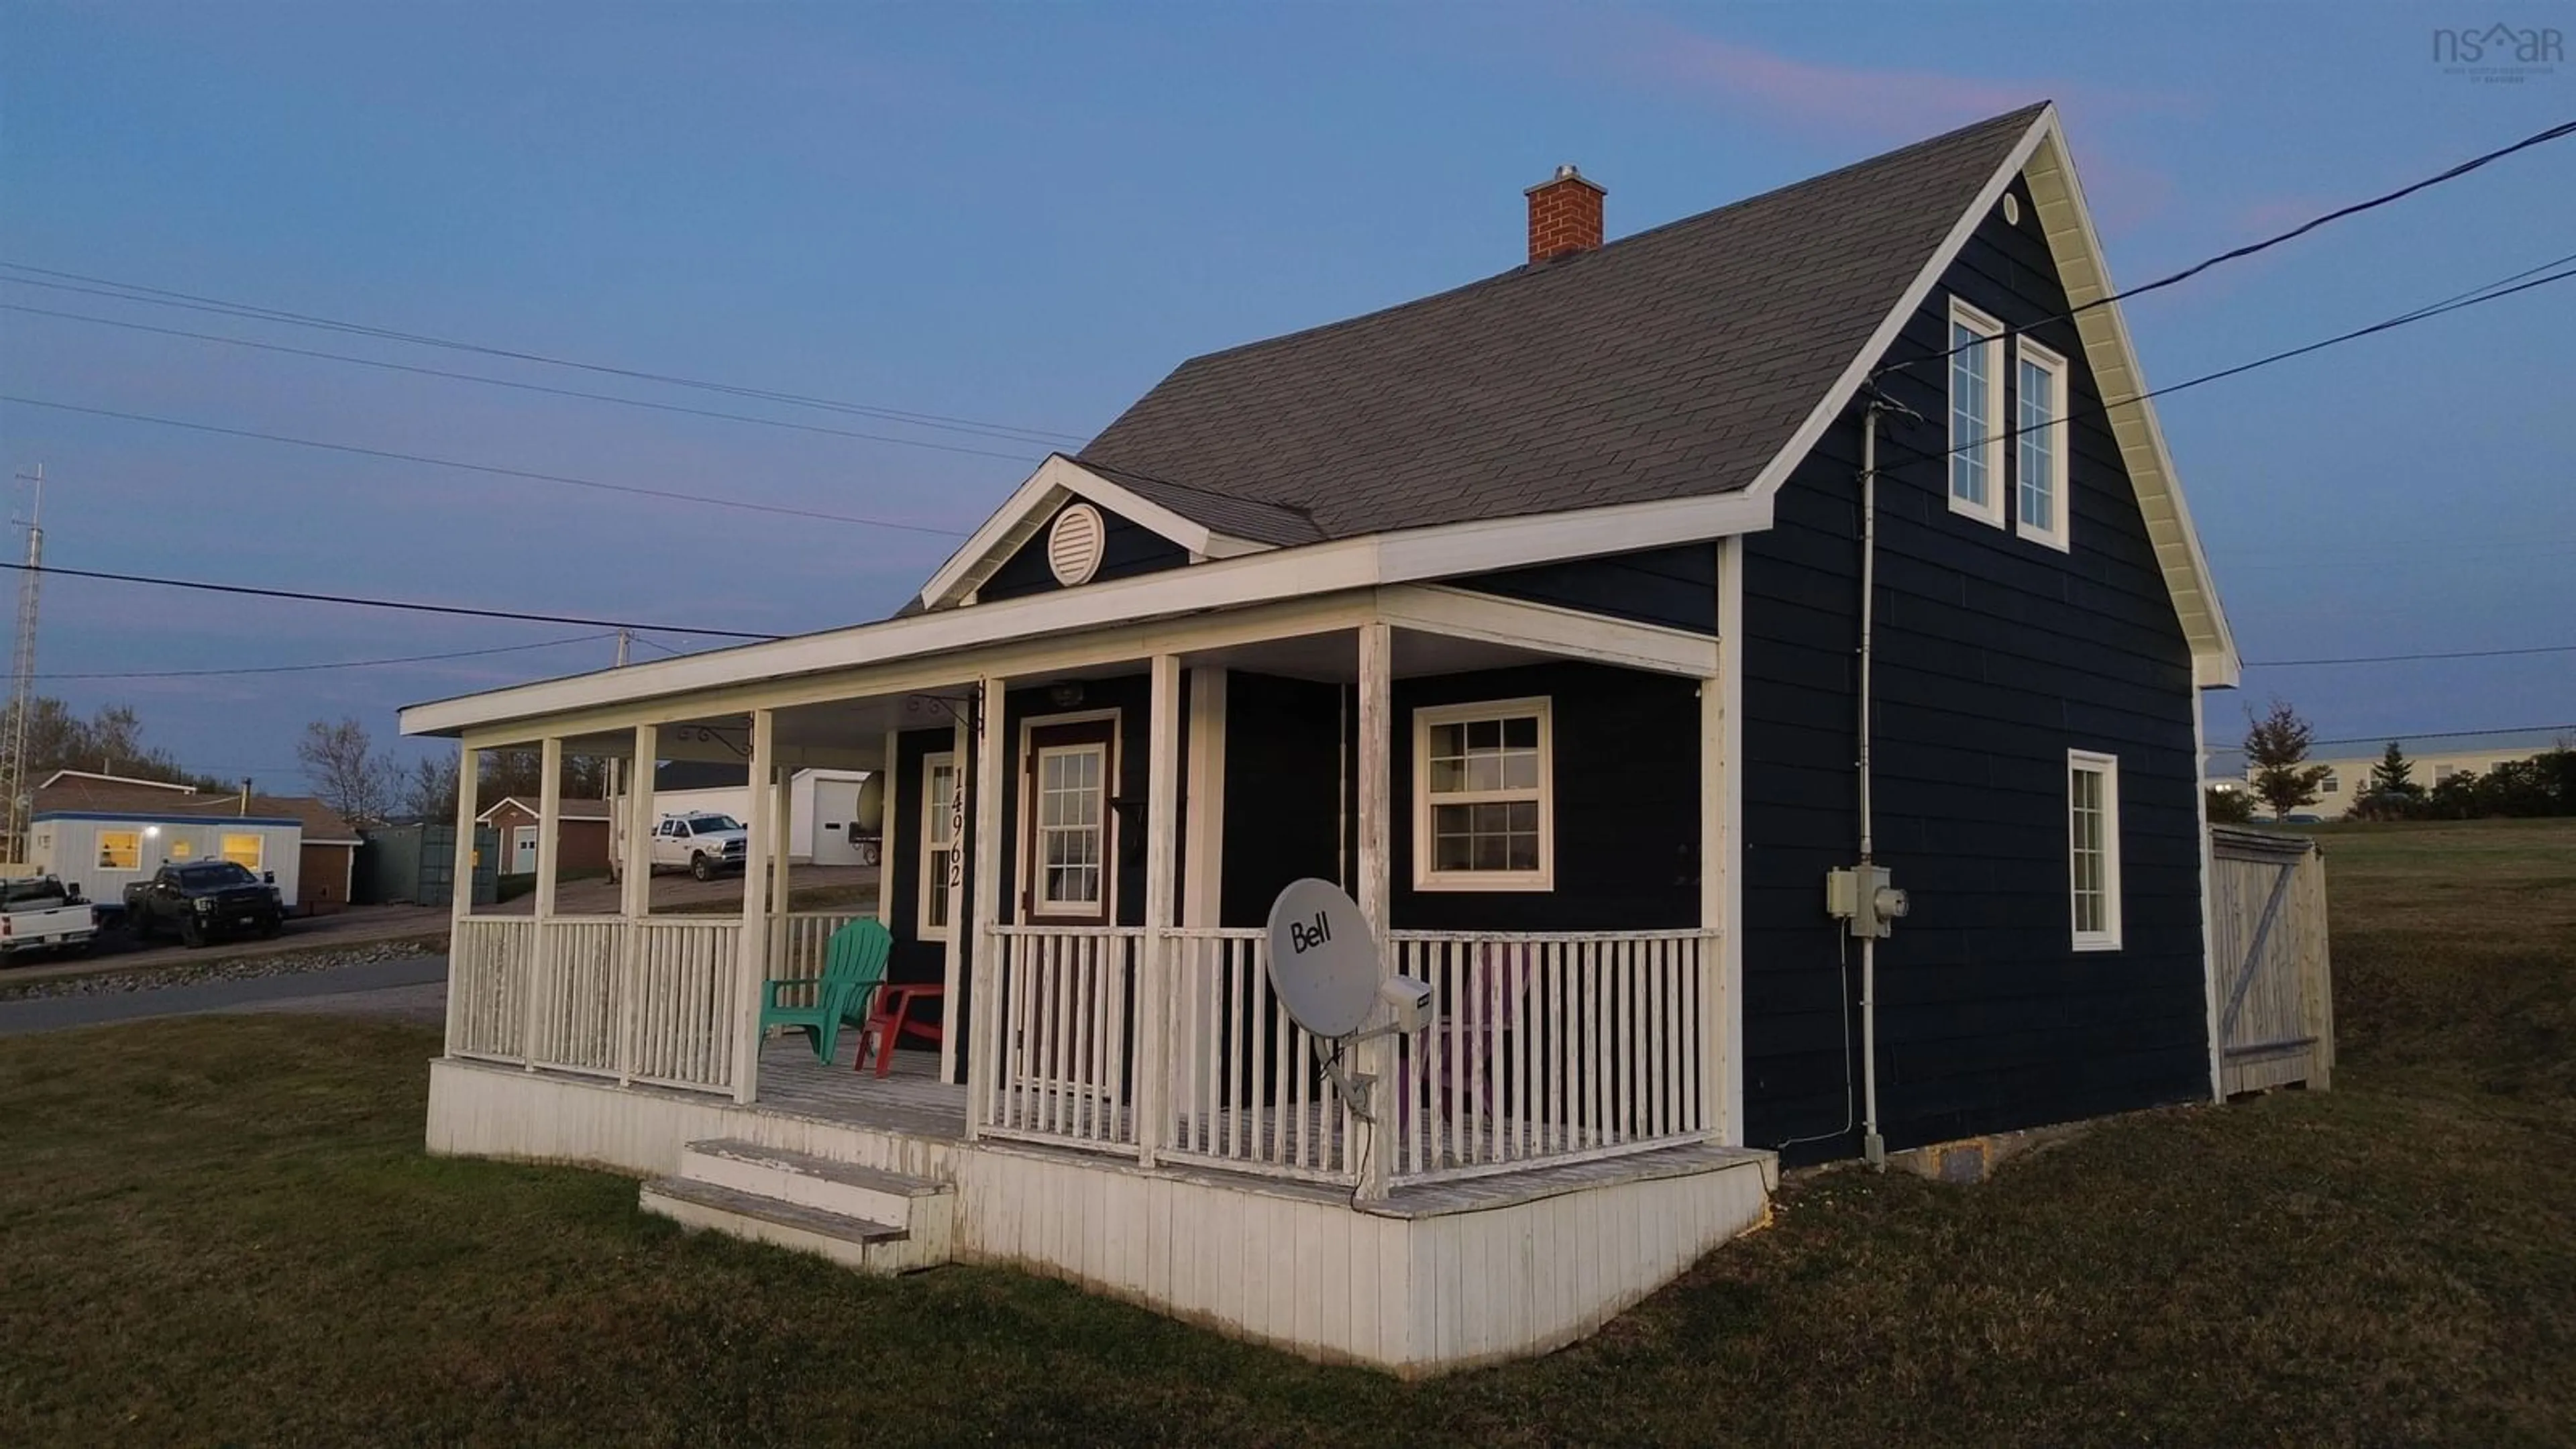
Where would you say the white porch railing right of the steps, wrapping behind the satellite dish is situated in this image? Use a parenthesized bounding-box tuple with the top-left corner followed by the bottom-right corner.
(974, 926, 1718, 1183)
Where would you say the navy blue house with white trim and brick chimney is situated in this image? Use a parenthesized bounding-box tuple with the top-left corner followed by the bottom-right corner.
(405, 106, 2239, 1165)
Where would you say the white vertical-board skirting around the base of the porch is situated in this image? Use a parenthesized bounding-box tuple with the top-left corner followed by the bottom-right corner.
(427, 1057, 1778, 1377)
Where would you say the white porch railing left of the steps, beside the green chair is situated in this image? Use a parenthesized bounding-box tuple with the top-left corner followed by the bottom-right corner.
(448, 915, 742, 1093)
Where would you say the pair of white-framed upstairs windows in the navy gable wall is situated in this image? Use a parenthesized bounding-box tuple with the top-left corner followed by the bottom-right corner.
(1950, 297, 2066, 549)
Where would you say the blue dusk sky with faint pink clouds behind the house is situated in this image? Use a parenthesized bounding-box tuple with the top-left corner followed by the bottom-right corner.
(0, 0, 2576, 789)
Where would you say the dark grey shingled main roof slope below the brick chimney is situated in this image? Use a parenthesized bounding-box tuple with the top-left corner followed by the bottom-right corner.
(1079, 106, 2040, 544)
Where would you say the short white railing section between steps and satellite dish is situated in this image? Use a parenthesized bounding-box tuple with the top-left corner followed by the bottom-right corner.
(971, 926, 1144, 1150)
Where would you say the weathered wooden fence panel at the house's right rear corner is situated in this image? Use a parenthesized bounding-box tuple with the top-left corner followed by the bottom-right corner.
(2210, 825, 2334, 1095)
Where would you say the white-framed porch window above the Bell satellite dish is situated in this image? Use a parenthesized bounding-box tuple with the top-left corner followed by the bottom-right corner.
(1414, 699, 1556, 890)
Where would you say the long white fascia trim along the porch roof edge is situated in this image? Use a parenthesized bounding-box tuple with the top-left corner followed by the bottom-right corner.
(402, 495, 1772, 742)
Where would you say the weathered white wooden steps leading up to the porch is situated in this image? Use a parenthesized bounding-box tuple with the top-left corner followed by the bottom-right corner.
(639, 1137, 956, 1274)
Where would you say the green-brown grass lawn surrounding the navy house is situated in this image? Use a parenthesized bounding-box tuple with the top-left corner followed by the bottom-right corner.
(0, 822, 2576, 1446)
